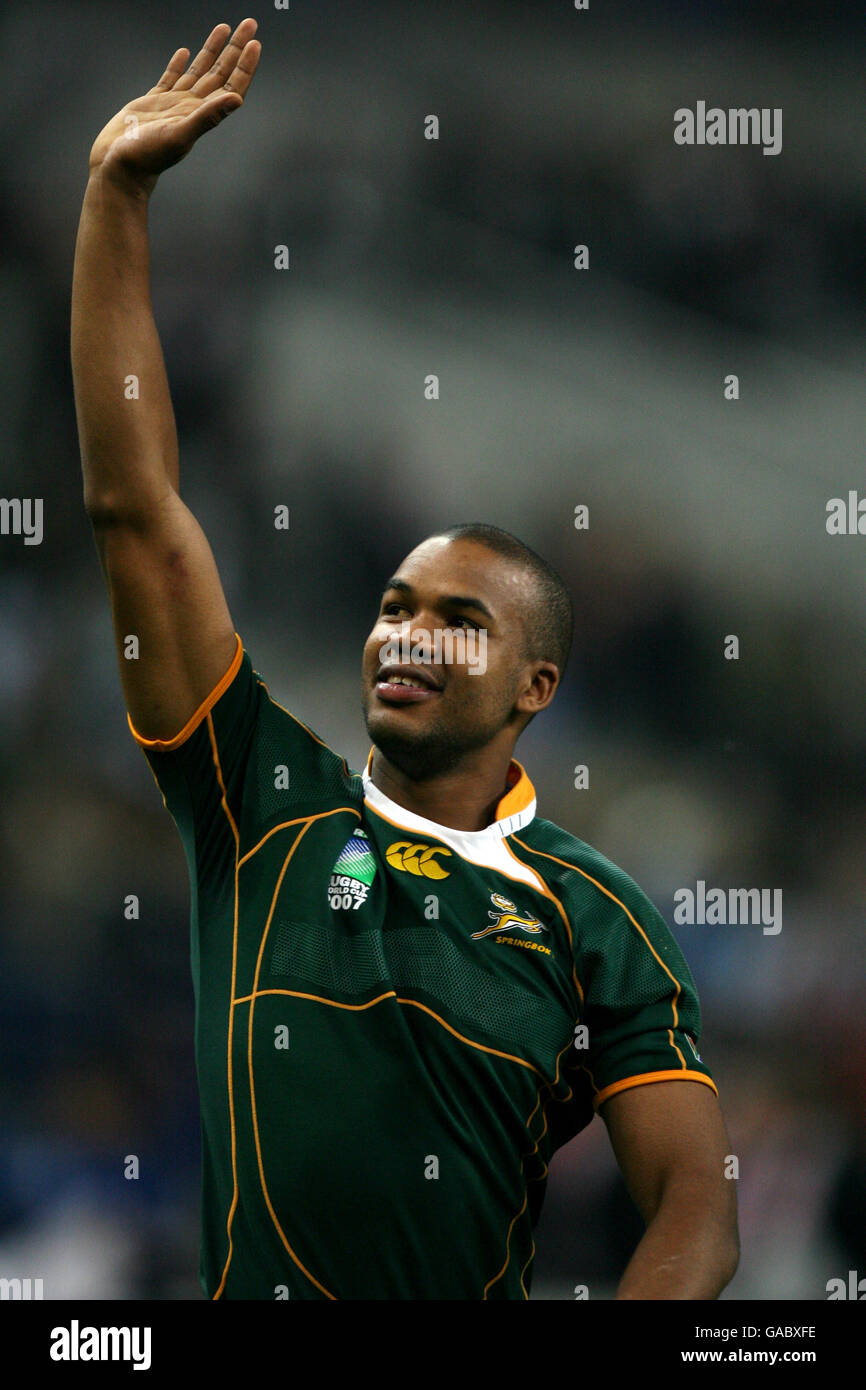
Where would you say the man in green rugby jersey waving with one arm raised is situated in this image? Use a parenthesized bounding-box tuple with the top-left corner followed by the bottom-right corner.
(72, 19, 738, 1300)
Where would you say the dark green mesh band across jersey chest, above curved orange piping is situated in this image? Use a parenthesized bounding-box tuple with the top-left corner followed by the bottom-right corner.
(271, 922, 571, 1056)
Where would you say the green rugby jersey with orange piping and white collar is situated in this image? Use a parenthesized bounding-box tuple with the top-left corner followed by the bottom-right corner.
(129, 638, 716, 1300)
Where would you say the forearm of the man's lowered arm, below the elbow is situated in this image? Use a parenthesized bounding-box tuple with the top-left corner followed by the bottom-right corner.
(616, 1191, 740, 1300)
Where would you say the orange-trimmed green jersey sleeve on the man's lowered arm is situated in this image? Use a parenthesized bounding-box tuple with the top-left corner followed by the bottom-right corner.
(575, 866, 717, 1109)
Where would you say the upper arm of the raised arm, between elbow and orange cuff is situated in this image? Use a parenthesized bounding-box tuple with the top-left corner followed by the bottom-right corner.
(92, 492, 238, 739)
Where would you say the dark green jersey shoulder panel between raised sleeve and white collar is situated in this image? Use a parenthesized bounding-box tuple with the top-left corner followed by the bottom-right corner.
(246, 691, 363, 821)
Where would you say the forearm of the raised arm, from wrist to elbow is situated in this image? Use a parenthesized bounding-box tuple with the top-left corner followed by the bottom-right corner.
(71, 170, 178, 516)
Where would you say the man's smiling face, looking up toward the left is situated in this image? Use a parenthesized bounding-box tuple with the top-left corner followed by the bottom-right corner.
(363, 537, 555, 780)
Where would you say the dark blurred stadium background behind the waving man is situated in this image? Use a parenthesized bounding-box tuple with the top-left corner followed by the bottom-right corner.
(0, 0, 866, 1300)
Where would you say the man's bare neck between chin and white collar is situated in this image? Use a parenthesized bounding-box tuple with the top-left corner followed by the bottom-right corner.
(370, 748, 512, 830)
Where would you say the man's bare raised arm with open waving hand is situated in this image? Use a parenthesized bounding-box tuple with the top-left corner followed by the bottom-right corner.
(71, 19, 261, 739)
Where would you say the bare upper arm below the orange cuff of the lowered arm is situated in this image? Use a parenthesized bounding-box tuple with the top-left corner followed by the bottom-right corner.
(599, 1080, 735, 1222)
